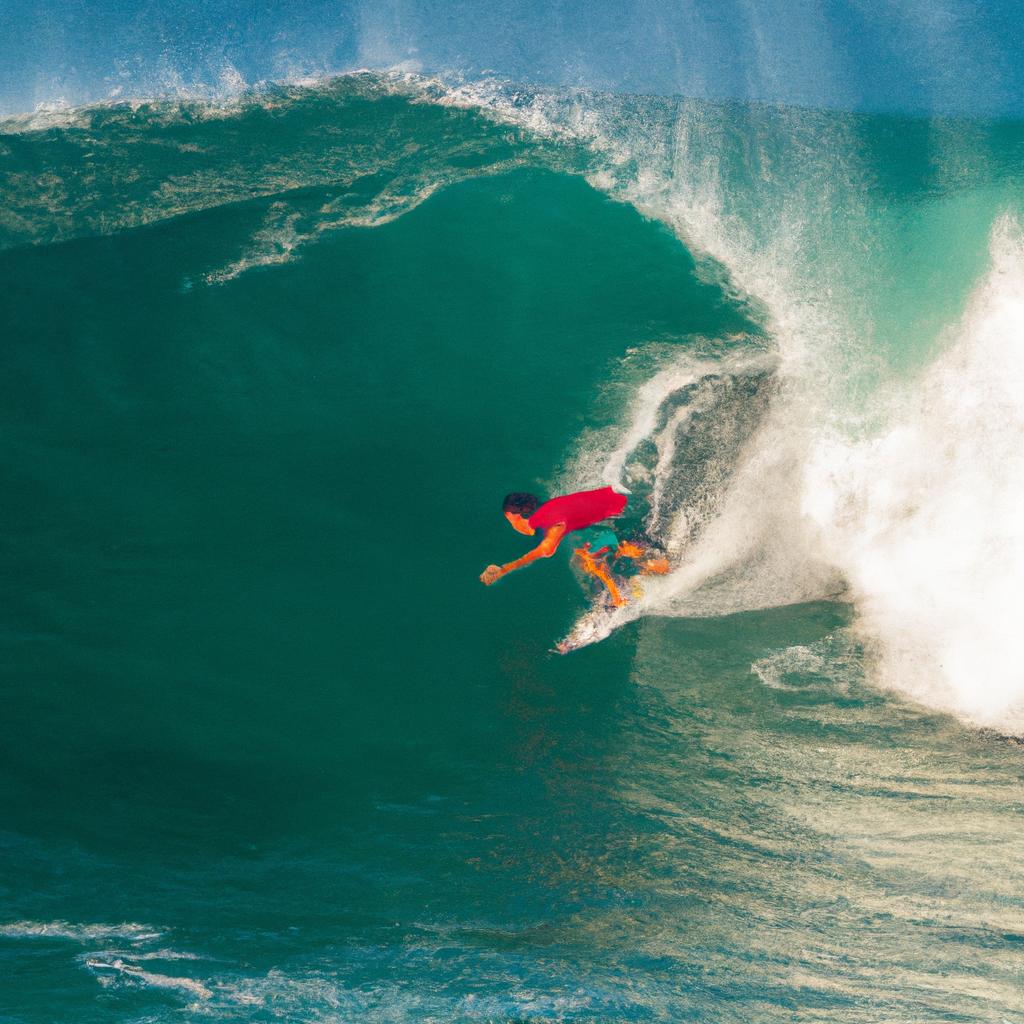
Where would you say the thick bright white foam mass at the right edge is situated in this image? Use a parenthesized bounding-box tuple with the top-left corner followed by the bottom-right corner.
(804, 216, 1024, 732)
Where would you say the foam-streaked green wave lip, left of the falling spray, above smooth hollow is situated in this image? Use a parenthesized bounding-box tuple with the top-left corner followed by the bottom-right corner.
(0, 75, 577, 248)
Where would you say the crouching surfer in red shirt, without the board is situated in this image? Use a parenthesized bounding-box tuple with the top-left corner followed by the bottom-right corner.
(480, 487, 669, 606)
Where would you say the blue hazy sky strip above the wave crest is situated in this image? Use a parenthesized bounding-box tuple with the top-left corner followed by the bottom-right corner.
(0, 0, 1024, 116)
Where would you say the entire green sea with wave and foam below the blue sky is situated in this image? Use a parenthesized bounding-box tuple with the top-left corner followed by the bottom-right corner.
(0, 72, 1024, 1024)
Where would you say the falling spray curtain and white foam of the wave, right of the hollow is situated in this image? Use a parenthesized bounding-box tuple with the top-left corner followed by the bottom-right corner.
(450, 84, 1024, 732)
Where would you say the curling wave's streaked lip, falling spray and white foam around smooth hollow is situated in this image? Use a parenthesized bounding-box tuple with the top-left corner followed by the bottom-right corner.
(8, 73, 1024, 731)
